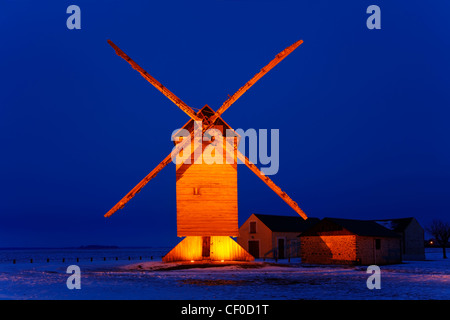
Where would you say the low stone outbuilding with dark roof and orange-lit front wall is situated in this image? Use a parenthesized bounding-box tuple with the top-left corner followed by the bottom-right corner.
(300, 218, 402, 265)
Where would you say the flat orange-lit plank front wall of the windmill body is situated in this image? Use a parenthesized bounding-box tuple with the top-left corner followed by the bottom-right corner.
(176, 136, 239, 237)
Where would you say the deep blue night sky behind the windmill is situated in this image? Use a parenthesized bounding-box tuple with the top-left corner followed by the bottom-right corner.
(0, 0, 450, 247)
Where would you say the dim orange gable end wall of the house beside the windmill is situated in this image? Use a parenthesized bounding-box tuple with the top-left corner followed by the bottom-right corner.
(237, 214, 272, 258)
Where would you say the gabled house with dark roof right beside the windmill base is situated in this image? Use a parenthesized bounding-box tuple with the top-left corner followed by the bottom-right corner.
(237, 213, 320, 259)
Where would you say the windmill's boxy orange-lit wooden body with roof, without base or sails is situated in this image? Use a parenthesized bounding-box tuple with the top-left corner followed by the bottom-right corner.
(173, 106, 239, 237)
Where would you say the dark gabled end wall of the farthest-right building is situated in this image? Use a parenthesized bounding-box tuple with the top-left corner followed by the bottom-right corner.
(402, 219, 425, 260)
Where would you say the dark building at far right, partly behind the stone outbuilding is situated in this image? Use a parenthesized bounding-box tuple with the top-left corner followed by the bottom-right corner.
(374, 217, 425, 260)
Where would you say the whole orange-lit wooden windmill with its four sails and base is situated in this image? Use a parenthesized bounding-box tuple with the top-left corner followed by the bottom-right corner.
(105, 40, 307, 262)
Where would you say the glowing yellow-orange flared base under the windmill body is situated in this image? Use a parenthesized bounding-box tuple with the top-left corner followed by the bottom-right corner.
(162, 236, 255, 262)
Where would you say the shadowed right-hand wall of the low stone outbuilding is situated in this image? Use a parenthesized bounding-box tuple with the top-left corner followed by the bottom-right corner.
(356, 236, 402, 265)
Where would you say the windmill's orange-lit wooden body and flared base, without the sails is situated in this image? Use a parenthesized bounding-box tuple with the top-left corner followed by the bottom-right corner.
(169, 105, 248, 262)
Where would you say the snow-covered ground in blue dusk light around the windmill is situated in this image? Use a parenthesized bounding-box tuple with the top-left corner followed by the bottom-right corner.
(0, 249, 450, 300)
